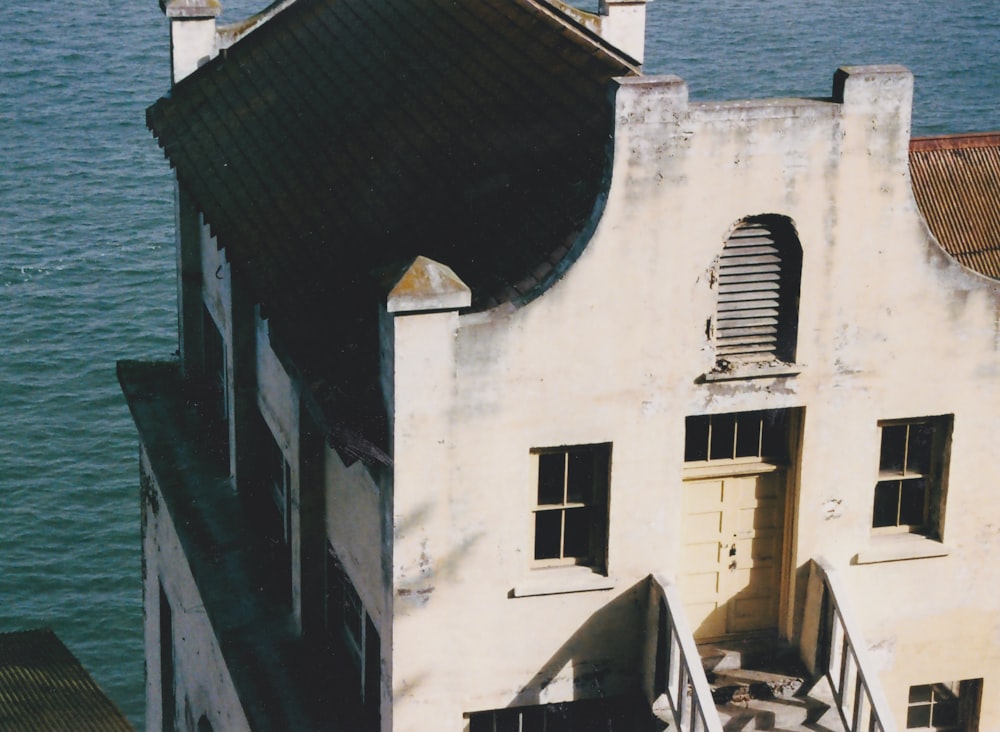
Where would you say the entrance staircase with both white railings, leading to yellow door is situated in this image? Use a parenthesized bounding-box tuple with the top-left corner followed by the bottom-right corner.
(644, 558, 896, 732)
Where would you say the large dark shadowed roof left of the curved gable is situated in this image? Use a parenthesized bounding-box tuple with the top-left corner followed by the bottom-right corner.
(147, 0, 639, 460)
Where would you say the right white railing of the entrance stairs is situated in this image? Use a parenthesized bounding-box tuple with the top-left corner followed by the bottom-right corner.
(807, 559, 896, 732)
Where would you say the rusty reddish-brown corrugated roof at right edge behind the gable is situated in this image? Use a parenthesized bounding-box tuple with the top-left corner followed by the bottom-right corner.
(910, 132, 1000, 279)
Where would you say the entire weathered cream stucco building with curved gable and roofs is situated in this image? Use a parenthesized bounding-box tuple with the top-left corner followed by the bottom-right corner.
(119, 0, 1000, 732)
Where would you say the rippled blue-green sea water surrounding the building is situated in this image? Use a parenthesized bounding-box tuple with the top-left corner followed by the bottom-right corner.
(0, 0, 1000, 728)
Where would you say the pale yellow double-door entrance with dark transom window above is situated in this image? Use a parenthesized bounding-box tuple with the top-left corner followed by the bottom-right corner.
(678, 410, 791, 641)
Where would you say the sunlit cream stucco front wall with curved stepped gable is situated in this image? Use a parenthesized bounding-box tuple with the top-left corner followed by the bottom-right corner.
(393, 67, 1000, 730)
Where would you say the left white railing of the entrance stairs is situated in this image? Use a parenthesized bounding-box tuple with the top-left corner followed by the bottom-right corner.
(651, 573, 723, 732)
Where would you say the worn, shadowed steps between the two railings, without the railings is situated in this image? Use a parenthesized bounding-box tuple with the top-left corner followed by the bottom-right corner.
(698, 638, 844, 732)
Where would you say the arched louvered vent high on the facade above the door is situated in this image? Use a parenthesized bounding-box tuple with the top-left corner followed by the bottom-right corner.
(715, 216, 802, 363)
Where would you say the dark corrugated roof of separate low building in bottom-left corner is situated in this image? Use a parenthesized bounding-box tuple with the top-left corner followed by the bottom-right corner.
(0, 629, 134, 732)
